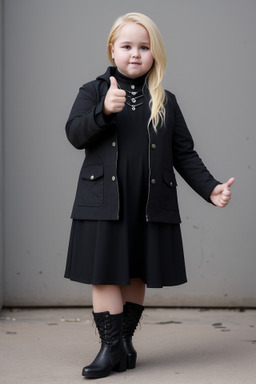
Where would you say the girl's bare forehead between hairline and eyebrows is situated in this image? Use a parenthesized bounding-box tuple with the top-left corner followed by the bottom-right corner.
(117, 22, 150, 44)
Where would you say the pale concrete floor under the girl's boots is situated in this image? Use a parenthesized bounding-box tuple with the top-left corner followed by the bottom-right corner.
(0, 308, 256, 384)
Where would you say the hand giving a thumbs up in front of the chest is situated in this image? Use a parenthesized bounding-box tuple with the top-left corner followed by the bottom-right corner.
(103, 76, 126, 115)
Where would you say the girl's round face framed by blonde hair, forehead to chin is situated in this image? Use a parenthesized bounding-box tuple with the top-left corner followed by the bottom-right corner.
(111, 23, 154, 79)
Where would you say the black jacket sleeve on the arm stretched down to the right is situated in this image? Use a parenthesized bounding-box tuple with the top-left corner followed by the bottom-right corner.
(173, 96, 221, 202)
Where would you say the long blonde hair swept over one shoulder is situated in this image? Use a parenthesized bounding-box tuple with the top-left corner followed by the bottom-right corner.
(107, 13, 167, 131)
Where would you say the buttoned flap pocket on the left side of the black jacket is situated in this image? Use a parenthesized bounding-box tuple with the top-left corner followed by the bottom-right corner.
(77, 164, 104, 207)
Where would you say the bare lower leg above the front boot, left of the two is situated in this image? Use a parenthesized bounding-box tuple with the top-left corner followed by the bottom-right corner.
(92, 285, 123, 315)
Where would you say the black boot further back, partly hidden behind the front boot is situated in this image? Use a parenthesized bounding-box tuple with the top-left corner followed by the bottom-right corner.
(123, 302, 144, 369)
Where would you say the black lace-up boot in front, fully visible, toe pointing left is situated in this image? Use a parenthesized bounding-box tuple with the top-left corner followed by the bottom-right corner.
(82, 312, 127, 379)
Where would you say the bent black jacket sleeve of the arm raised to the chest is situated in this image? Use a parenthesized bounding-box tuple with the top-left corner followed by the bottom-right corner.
(66, 81, 114, 149)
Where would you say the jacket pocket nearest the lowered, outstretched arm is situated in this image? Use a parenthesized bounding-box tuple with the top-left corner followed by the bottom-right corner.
(161, 171, 178, 210)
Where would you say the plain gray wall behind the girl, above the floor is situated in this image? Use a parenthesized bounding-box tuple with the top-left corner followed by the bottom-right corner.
(4, 0, 256, 306)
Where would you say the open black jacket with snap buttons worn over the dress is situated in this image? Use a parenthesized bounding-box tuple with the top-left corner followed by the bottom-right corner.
(66, 67, 219, 223)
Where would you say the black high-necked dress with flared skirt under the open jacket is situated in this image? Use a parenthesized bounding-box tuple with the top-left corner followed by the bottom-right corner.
(65, 72, 187, 288)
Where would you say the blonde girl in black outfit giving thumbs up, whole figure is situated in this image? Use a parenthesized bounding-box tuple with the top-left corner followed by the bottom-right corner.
(65, 13, 234, 378)
